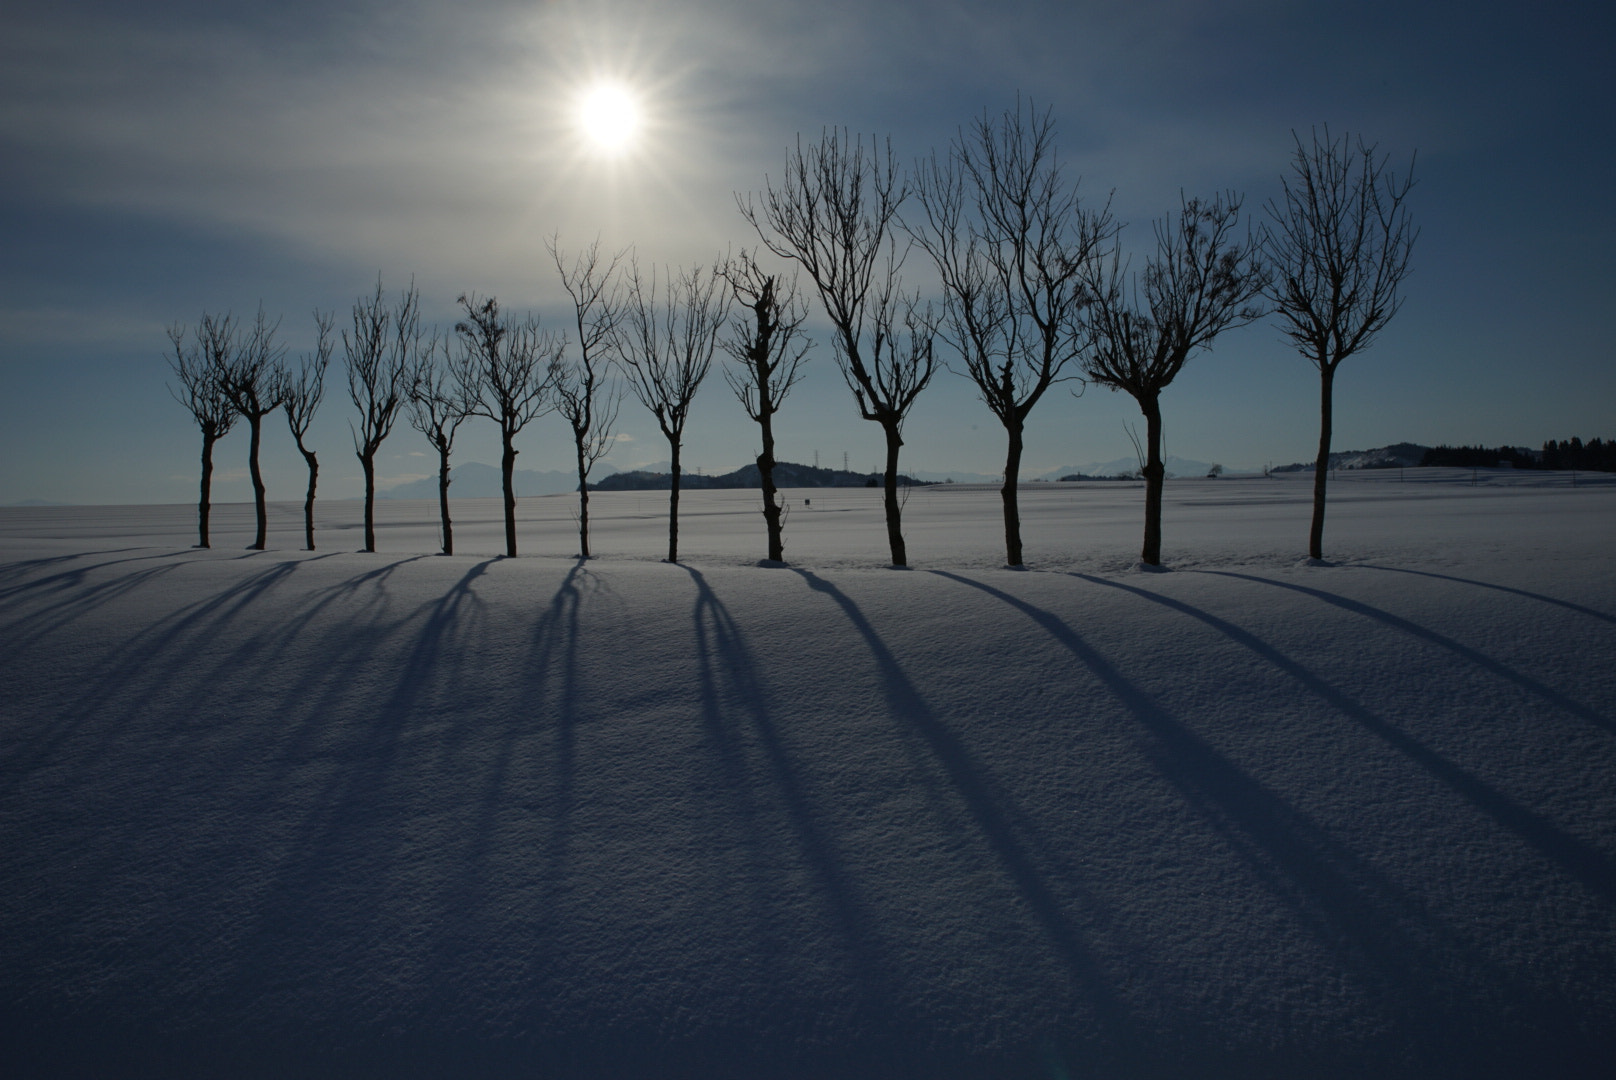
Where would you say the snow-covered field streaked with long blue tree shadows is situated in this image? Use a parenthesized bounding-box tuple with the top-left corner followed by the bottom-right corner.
(0, 469, 1616, 1080)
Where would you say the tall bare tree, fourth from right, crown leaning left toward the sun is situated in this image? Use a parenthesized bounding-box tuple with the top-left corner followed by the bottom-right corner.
(739, 131, 936, 566)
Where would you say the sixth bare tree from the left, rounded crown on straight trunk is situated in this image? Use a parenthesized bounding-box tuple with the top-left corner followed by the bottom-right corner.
(454, 294, 566, 558)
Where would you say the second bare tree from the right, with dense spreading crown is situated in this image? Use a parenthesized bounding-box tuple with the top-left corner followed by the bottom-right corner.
(1084, 192, 1267, 566)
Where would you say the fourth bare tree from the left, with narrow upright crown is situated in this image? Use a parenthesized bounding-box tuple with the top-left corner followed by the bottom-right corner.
(343, 278, 420, 551)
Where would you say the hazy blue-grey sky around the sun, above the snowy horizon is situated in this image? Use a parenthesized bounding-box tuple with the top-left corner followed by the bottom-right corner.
(0, 0, 1616, 503)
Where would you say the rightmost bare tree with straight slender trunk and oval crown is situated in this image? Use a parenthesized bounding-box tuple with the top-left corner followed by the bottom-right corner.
(1264, 128, 1419, 559)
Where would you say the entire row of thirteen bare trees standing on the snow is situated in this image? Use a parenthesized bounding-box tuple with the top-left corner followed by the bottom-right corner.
(171, 102, 1416, 567)
